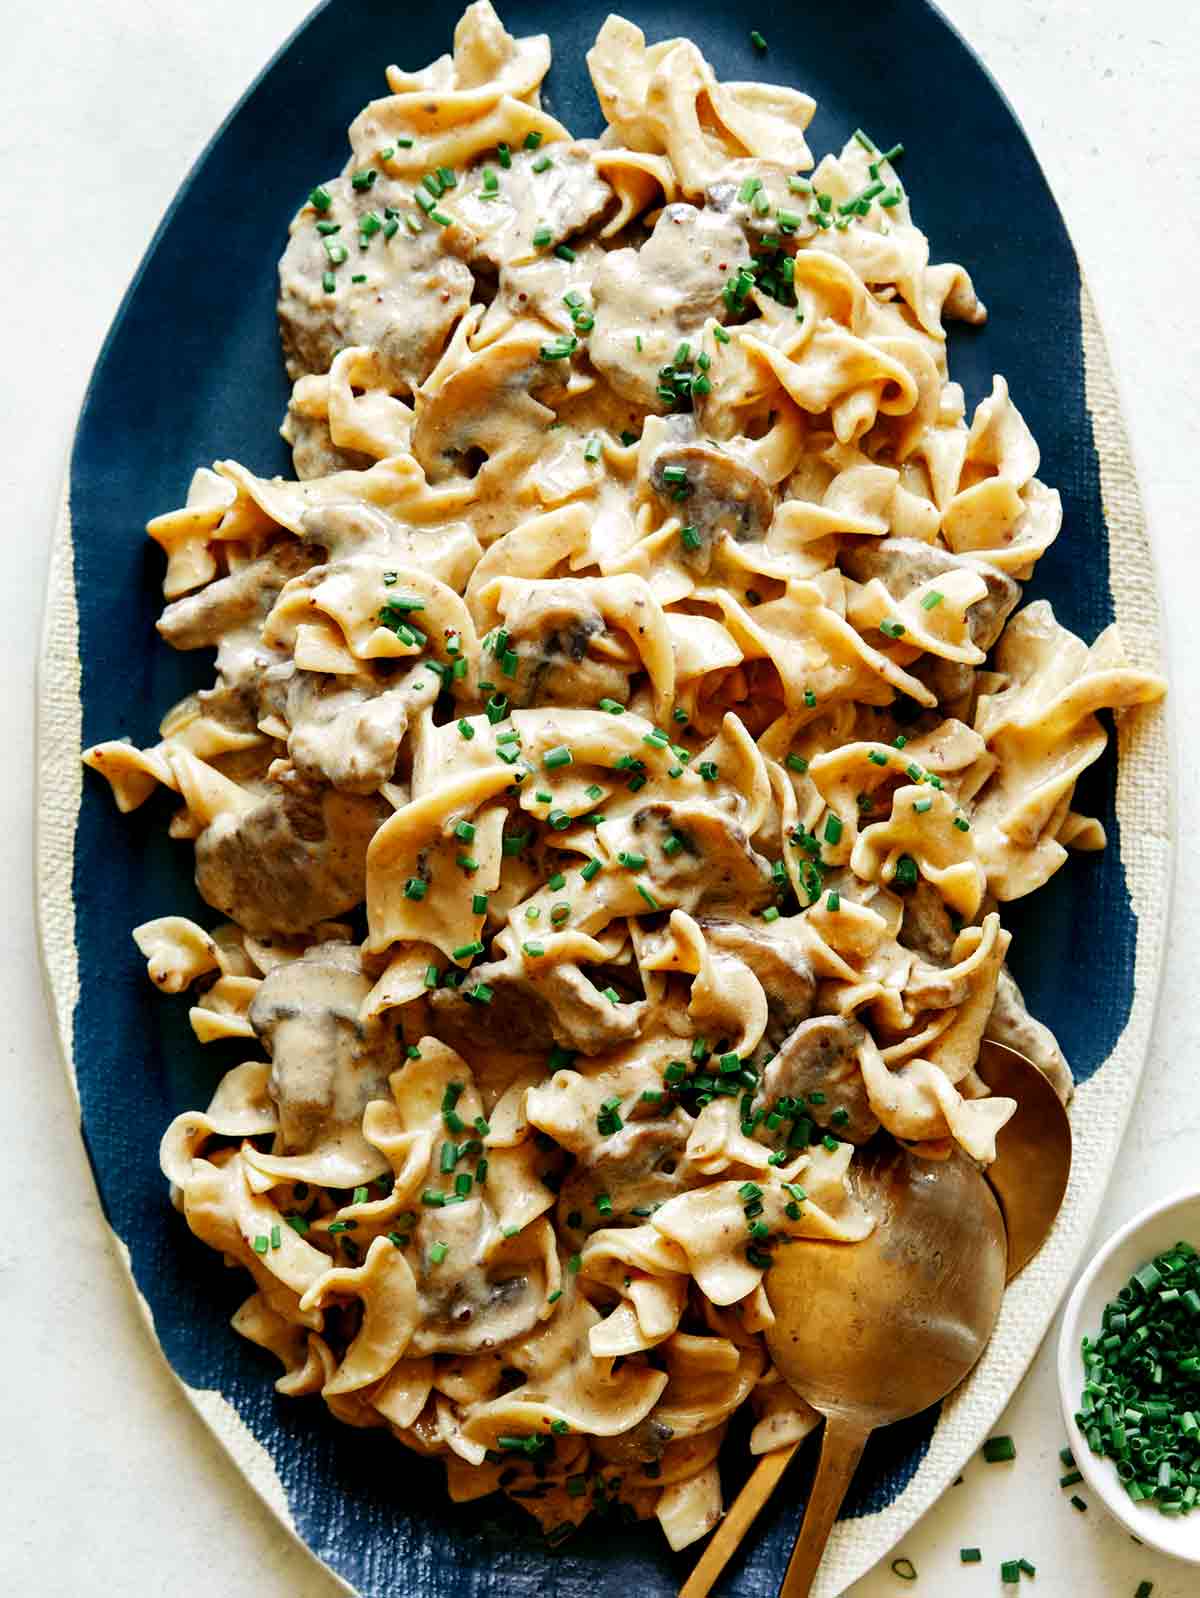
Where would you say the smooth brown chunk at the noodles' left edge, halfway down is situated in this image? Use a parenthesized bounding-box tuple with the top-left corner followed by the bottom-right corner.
(197, 772, 390, 935)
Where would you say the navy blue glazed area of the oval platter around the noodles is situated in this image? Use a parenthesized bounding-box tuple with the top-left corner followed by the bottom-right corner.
(70, 0, 1156, 1598)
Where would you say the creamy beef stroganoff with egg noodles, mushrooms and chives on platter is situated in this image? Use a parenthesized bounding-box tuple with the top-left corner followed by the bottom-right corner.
(85, 0, 1163, 1548)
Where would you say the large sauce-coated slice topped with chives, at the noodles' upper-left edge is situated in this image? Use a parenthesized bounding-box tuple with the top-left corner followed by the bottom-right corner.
(278, 176, 473, 388)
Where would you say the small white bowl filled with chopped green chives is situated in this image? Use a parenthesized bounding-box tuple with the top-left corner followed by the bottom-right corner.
(1058, 1192, 1200, 1564)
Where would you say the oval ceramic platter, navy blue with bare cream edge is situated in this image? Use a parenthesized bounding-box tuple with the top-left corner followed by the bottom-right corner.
(37, 0, 1171, 1598)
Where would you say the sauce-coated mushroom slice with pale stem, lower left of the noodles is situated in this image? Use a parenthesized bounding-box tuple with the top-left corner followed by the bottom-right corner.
(249, 943, 404, 1154)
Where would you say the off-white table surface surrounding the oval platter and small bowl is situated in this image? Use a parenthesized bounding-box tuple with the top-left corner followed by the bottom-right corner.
(0, 0, 1200, 1598)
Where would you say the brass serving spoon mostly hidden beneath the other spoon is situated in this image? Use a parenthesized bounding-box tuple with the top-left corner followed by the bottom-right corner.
(679, 1042, 1071, 1598)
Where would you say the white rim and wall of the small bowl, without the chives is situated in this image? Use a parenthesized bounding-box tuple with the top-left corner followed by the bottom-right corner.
(1058, 1192, 1200, 1564)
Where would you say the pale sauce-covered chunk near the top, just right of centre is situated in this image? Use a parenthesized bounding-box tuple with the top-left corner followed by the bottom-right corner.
(588, 205, 748, 411)
